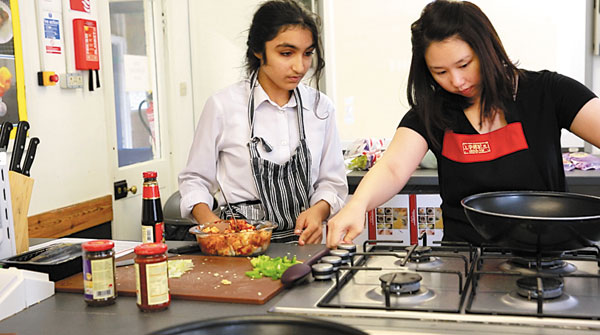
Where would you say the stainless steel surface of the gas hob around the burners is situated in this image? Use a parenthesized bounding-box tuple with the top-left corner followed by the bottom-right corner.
(269, 244, 600, 335)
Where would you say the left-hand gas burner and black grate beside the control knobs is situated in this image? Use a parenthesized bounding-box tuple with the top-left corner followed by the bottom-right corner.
(317, 241, 475, 313)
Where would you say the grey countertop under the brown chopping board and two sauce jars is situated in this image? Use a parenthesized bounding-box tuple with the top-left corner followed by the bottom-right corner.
(0, 241, 323, 335)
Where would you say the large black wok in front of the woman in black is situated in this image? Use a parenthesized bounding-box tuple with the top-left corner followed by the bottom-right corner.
(461, 191, 600, 254)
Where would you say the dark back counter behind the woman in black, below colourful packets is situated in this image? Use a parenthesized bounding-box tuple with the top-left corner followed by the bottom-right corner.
(347, 169, 600, 196)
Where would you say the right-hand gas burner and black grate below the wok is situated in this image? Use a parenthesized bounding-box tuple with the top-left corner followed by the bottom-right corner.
(465, 247, 600, 319)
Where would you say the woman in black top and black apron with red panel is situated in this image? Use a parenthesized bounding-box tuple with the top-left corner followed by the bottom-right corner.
(327, 0, 600, 247)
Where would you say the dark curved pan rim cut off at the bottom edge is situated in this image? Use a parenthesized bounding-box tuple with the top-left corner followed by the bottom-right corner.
(151, 315, 367, 335)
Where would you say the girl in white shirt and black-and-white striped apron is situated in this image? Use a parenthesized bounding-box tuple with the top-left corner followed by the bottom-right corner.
(179, 0, 348, 245)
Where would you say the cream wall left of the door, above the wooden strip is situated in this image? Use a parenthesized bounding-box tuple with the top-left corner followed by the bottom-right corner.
(18, 0, 113, 215)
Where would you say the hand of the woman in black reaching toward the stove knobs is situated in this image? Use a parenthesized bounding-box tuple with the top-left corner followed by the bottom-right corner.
(327, 202, 366, 249)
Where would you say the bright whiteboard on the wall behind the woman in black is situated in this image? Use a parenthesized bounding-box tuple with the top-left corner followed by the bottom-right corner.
(323, 0, 587, 147)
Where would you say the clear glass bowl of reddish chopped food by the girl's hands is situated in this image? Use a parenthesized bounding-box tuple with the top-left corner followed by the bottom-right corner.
(189, 219, 277, 256)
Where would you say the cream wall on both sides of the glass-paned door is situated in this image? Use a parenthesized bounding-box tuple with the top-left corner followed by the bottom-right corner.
(15, 0, 259, 220)
